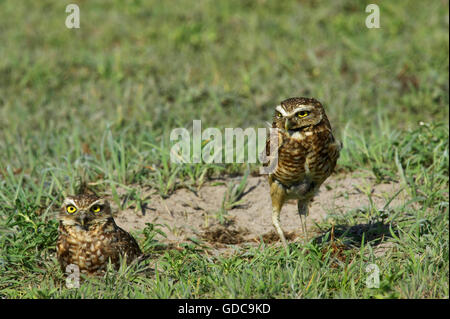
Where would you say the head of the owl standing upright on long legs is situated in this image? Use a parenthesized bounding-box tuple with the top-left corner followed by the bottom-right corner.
(273, 97, 326, 133)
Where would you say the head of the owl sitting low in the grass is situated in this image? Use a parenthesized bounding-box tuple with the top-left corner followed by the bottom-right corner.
(59, 195, 112, 230)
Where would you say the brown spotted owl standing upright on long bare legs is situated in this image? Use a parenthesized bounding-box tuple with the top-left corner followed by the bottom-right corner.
(266, 97, 341, 247)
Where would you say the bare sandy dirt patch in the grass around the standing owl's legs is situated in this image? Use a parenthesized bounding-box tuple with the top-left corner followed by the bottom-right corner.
(111, 172, 407, 247)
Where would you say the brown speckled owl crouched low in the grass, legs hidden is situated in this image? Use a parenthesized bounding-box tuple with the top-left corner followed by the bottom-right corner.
(57, 195, 141, 274)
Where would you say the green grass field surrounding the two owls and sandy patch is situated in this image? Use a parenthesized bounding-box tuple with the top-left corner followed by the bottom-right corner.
(0, 0, 449, 298)
